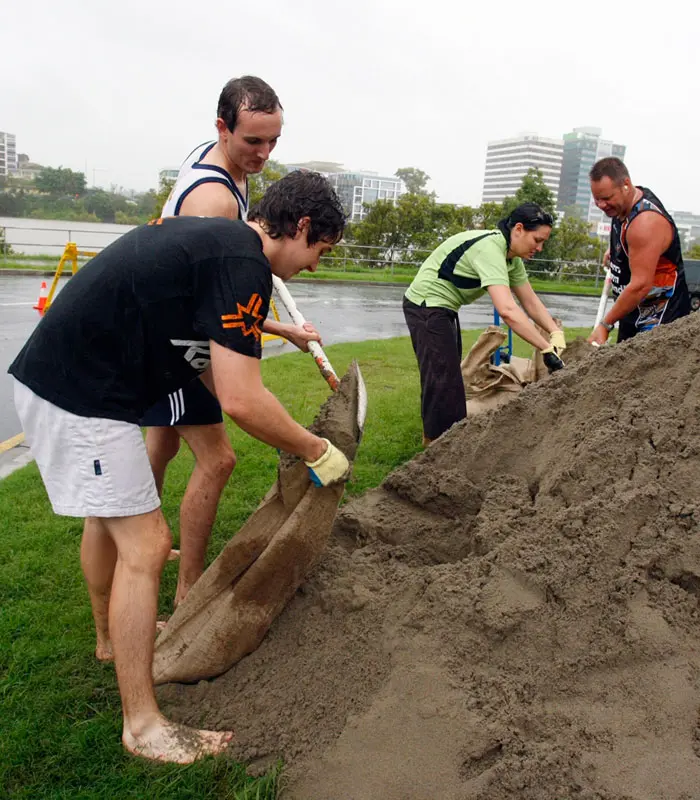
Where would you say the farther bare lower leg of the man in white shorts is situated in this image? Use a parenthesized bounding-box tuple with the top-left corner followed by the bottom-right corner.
(80, 517, 117, 661)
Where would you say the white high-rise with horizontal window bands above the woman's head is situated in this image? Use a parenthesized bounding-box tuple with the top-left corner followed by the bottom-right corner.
(481, 133, 564, 203)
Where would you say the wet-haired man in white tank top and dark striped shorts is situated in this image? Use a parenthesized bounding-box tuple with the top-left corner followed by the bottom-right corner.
(141, 76, 320, 605)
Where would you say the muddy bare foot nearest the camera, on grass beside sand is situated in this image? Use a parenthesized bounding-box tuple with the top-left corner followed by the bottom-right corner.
(122, 717, 234, 764)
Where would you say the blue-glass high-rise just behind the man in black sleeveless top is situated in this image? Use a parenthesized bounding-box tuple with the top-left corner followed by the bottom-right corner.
(557, 127, 627, 224)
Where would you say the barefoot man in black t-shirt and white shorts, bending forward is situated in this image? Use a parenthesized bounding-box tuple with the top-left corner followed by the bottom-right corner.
(9, 172, 349, 763)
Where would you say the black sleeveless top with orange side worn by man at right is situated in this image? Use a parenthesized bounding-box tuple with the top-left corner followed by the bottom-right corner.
(610, 186, 690, 339)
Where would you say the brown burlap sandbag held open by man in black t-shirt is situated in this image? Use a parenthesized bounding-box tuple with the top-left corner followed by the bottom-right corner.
(153, 362, 364, 683)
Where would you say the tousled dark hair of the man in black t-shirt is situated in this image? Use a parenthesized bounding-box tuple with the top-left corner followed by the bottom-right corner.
(248, 170, 345, 245)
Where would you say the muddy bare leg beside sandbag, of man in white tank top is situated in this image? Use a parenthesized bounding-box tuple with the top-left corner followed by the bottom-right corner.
(175, 422, 236, 606)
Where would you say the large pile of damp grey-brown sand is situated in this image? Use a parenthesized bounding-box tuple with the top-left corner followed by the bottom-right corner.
(160, 314, 700, 800)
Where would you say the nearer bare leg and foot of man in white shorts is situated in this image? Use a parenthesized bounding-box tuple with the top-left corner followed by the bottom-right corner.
(101, 509, 233, 764)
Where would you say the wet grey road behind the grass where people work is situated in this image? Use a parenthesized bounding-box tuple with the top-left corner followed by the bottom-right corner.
(0, 275, 598, 442)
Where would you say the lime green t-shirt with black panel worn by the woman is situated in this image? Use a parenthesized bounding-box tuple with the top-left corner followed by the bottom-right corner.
(406, 231, 528, 311)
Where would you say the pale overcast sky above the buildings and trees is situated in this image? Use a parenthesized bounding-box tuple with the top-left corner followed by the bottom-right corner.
(0, 0, 700, 213)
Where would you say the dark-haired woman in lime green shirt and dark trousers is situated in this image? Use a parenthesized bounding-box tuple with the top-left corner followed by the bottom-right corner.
(403, 203, 566, 444)
